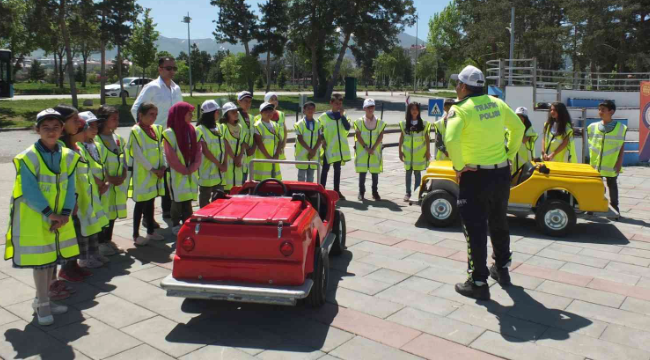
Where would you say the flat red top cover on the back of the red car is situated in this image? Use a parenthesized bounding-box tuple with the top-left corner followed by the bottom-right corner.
(192, 195, 304, 225)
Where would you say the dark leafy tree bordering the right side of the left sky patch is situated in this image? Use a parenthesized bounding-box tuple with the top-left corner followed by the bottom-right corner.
(210, 0, 258, 93)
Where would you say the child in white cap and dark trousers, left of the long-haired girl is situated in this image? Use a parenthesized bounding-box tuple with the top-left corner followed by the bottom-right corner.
(354, 99, 386, 201)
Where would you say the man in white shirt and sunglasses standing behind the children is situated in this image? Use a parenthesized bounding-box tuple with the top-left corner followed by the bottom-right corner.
(131, 57, 183, 129)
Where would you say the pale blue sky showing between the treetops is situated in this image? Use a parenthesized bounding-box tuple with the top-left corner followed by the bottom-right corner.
(138, 0, 449, 39)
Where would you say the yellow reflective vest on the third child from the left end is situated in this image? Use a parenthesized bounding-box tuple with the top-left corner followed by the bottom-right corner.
(75, 143, 108, 237)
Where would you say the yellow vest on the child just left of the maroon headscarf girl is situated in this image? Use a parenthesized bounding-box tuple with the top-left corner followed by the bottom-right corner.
(128, 124, 165, 202)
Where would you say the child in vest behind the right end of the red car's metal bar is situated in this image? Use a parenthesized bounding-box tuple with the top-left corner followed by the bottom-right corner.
(293, 101, 323, 182)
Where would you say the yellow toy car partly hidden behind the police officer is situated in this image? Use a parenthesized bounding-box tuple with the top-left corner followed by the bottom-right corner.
(418, 161, 616, 236)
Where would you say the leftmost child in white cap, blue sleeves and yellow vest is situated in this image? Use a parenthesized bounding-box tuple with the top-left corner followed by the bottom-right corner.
(5, 109, 79, 326)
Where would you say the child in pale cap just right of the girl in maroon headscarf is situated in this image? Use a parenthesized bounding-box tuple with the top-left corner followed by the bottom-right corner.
(196, 100, 227, 207)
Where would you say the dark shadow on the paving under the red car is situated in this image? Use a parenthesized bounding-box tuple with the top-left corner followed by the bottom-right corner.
(165, 251, 354, 354)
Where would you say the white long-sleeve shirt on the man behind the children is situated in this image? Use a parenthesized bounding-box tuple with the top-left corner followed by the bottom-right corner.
(131, 76, 183, 128)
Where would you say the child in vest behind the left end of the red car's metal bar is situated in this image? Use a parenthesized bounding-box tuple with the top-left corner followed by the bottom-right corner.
(254, 102, 282, 181)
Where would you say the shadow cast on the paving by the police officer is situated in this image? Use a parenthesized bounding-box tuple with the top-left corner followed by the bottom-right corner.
(477, 284, 593, 342)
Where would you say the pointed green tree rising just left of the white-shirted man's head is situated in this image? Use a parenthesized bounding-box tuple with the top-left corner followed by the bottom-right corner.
(126, 8, 160, 95)
